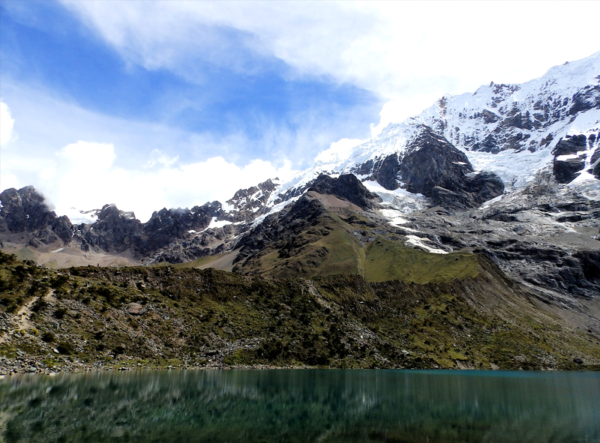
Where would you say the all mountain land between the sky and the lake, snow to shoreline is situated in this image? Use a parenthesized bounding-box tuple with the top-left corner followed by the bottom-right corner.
(0, 52, 600, 374)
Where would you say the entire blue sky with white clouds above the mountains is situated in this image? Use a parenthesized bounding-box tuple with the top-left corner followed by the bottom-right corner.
(0, 0, 600, 221)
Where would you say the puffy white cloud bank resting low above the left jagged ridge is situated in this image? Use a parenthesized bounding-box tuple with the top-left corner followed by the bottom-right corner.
(21, 141, 297, 221)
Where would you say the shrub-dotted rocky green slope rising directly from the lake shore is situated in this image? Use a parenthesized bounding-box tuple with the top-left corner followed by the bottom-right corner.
(0, 250, 600, 373)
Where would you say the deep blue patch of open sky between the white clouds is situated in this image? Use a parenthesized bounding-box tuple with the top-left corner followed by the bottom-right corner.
(0, 0, 382, 162)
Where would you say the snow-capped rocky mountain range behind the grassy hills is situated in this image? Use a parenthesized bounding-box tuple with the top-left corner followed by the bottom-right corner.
(0, 52, 600, 295)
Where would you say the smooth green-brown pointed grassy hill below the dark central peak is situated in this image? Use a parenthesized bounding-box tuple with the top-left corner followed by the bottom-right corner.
(235, 203, 479, 284)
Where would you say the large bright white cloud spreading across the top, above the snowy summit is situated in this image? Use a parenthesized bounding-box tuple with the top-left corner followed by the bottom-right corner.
(63, 0, 600, 125)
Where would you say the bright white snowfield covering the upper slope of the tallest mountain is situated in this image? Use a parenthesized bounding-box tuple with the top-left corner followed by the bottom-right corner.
(277, 52, 600, 205)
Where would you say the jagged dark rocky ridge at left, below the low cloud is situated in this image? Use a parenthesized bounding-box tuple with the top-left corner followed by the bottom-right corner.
(0, 180, 276, 263)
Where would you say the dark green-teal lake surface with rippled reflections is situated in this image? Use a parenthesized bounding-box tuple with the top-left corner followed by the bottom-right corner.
(0, 370, 600, 443)
